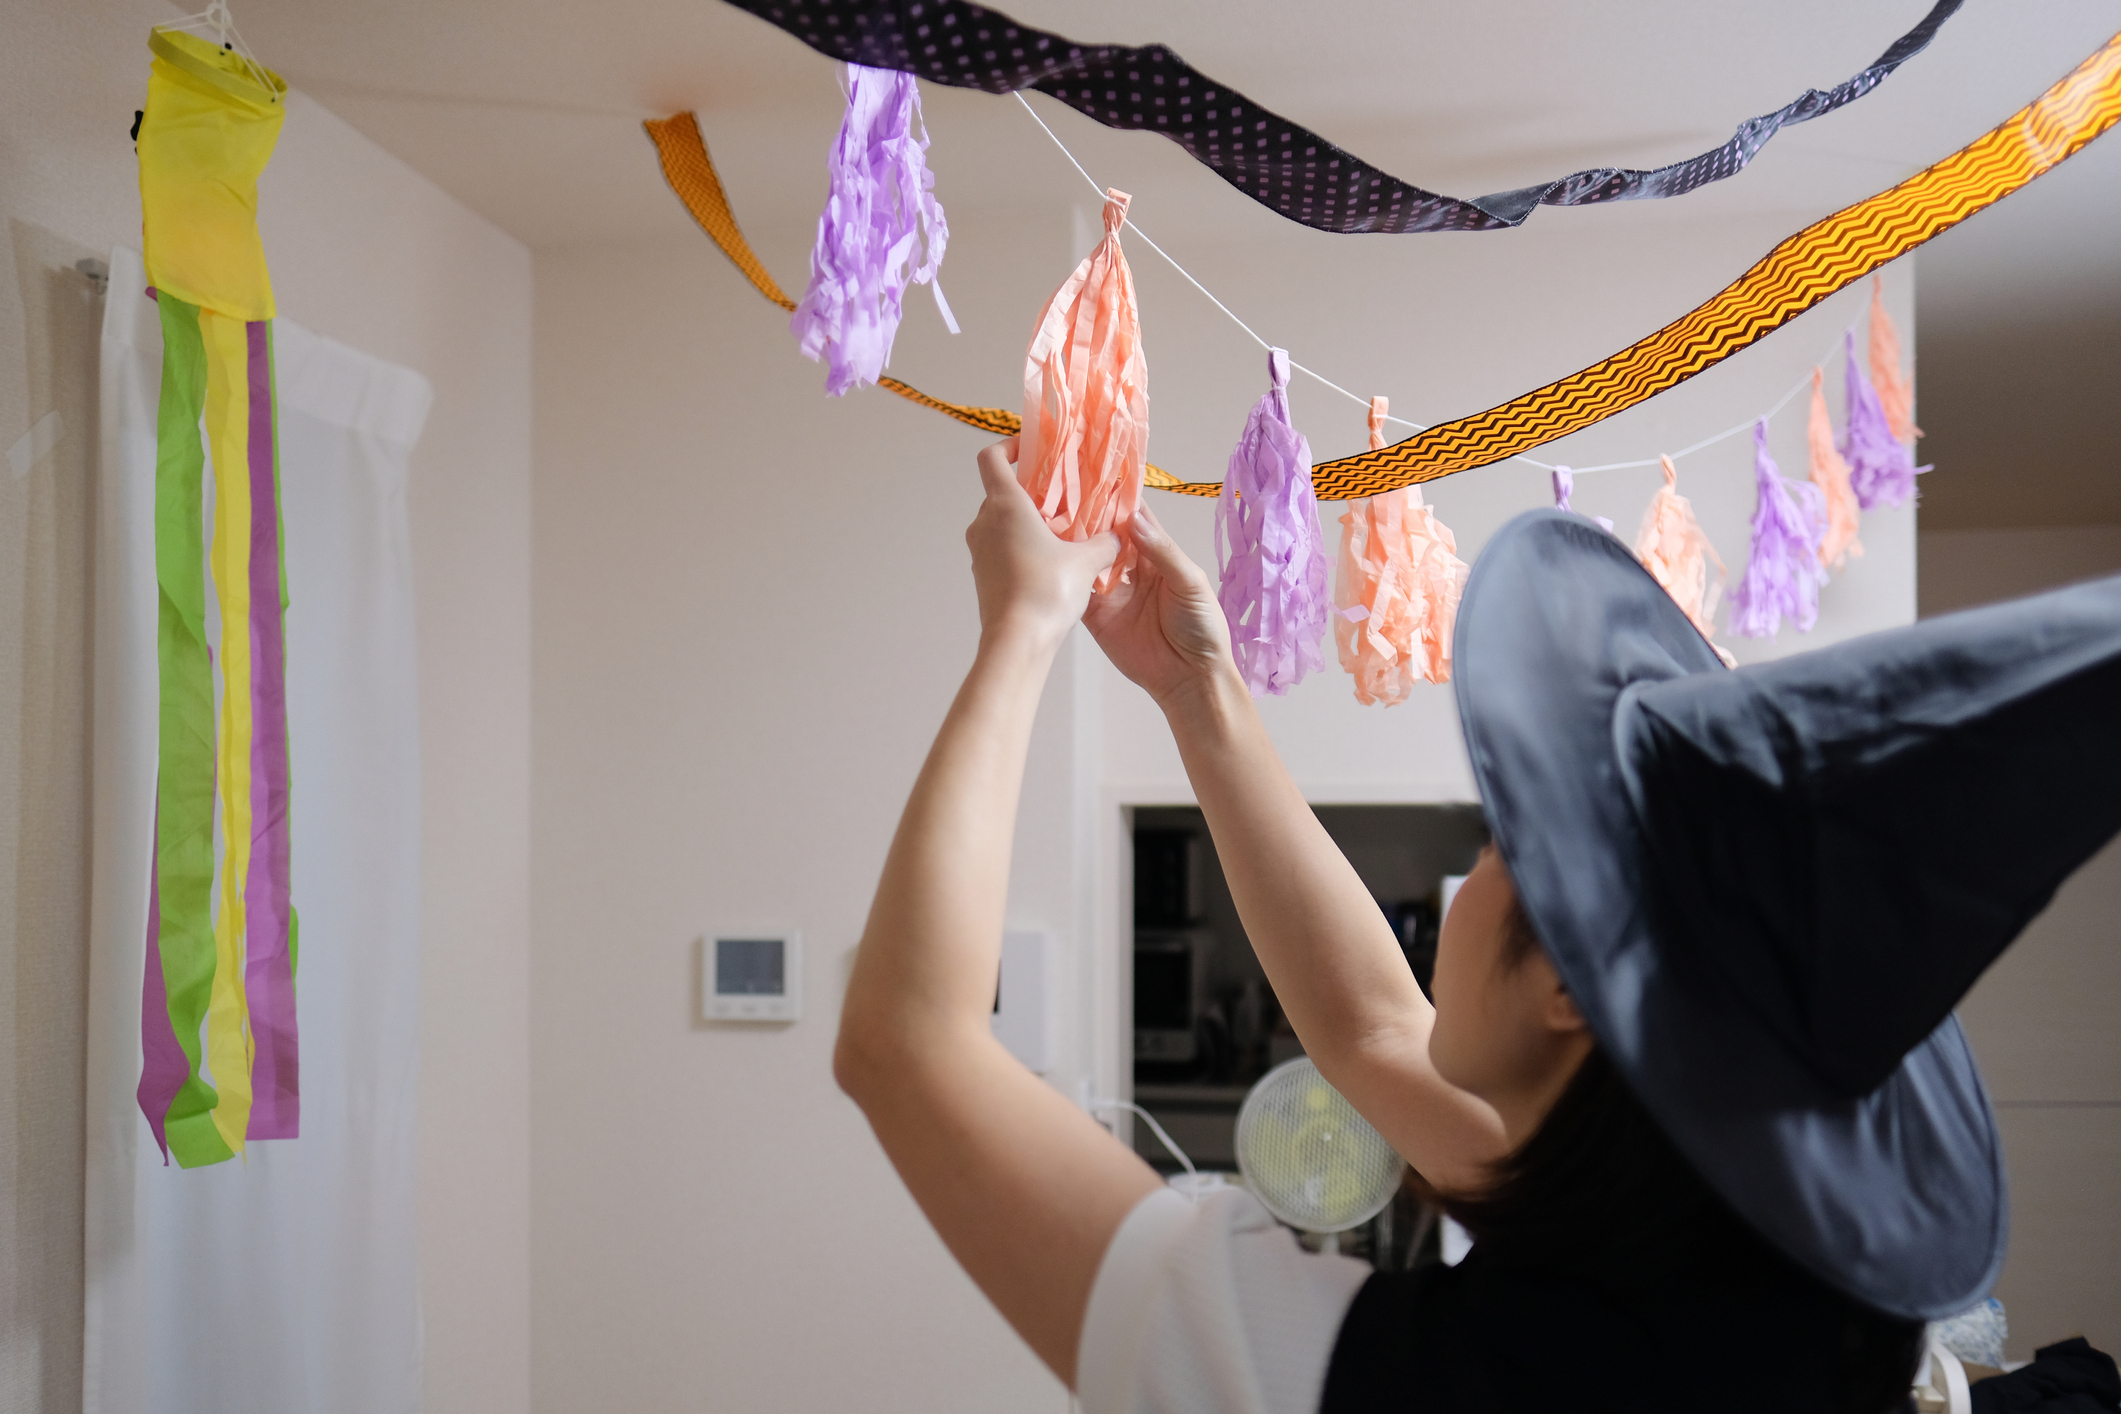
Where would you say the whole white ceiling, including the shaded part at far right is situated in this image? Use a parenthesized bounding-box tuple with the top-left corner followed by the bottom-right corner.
(235, 0, 2121, 524)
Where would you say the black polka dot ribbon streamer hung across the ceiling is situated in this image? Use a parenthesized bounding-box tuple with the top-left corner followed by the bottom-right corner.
(730, 0, 1962, 235)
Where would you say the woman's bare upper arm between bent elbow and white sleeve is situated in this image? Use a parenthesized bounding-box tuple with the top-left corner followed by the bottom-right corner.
(840, 1032, 1162, 1389)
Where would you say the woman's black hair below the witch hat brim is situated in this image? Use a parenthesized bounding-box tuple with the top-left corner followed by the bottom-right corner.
(1432, 899, 1924, 1414)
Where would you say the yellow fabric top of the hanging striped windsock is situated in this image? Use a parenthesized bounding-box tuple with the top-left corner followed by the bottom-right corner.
(140, 30, 286, 320)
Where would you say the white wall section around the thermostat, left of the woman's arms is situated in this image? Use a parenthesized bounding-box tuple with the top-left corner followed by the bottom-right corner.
(532, 214, 1067, 1414)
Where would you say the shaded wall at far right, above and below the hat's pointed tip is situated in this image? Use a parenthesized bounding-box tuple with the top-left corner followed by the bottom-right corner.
(1922, 526, 2121, 1359)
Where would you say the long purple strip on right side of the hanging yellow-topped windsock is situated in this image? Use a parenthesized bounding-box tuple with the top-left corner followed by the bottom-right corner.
(244, 320, 301, 1138)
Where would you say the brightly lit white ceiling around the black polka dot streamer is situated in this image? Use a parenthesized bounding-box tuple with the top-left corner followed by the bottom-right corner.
(238, 0, 2121, 264)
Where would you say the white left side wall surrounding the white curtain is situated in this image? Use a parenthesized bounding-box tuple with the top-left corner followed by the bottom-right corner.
(0, 0, 530, 1414)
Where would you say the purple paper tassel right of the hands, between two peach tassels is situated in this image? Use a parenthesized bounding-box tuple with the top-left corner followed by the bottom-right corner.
(1215, 348, 1330, 697)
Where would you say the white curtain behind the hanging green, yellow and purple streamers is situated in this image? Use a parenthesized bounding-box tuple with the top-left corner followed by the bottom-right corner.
(85, 250, 431, 1414)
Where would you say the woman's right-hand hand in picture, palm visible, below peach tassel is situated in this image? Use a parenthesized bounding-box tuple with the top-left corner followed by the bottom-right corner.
(1082, 507, 1237, 708)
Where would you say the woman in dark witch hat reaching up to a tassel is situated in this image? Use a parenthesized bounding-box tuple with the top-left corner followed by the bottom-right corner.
(836, 443, 2121, 1414)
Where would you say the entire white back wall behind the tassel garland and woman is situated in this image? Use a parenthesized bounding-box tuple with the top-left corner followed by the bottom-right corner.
(532, 91, 1915, 1414)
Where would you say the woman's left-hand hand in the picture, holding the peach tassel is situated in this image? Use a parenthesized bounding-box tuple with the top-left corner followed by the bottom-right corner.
(965, 437, 1120, 649)
